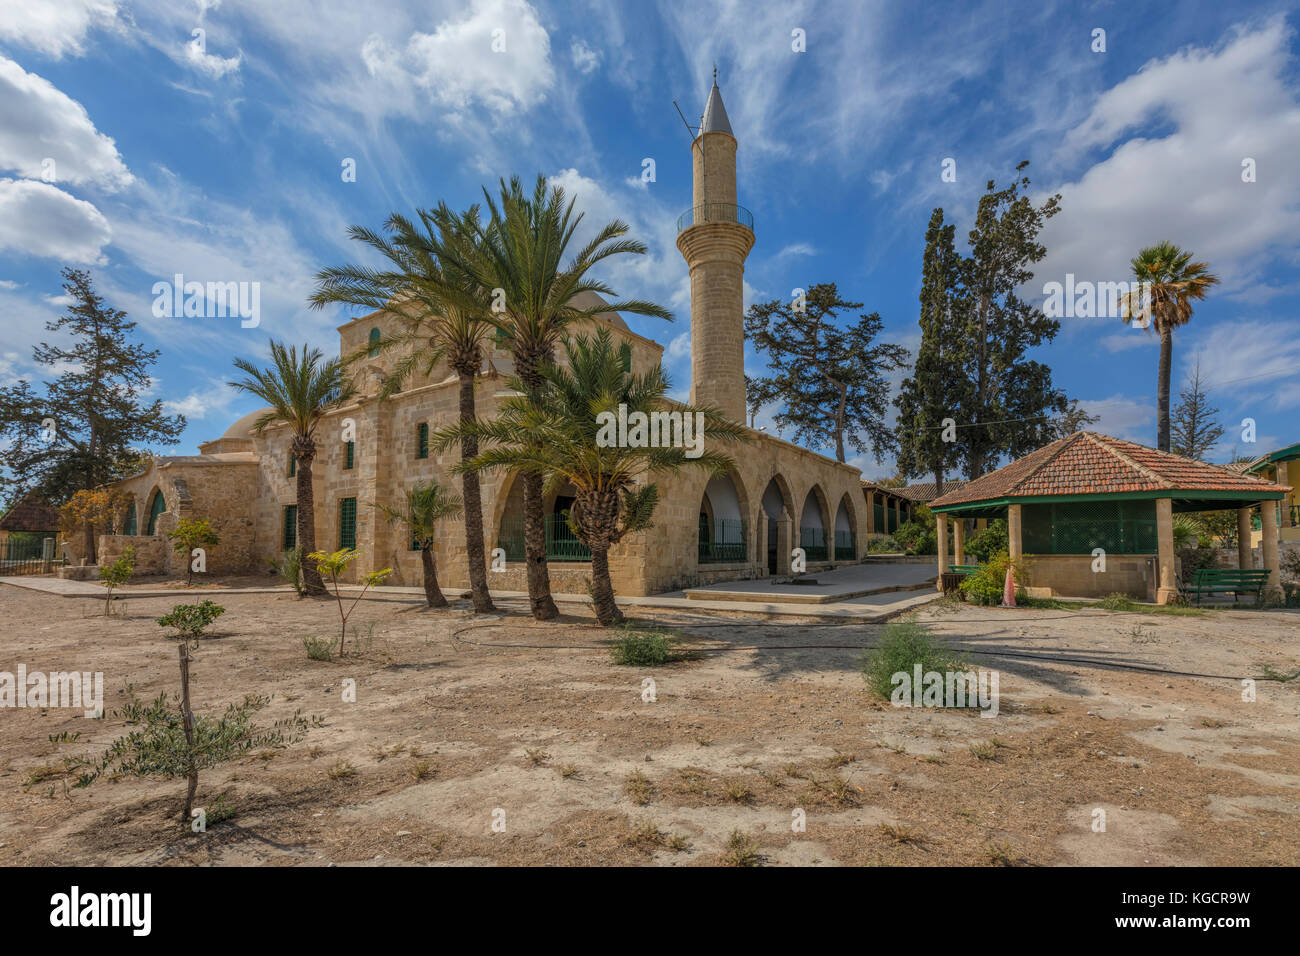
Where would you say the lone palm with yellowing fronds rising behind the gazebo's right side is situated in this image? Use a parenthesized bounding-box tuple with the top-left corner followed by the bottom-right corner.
(1121, 239, 1218, 451)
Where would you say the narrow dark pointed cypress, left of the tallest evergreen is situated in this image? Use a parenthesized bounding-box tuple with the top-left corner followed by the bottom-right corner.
(894, 209, 971, 494)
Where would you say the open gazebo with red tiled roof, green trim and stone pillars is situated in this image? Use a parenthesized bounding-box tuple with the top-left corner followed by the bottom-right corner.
(930, 432, 1291, 604)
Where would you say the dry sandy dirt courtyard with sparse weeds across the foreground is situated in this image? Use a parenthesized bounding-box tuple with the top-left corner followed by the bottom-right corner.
(0, 585, 1300, 866)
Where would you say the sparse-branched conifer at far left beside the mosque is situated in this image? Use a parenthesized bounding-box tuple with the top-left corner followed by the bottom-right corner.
(0, 268, 185, 538)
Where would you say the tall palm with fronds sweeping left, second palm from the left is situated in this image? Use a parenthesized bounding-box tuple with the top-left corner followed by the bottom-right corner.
(311, 203, 497, 614)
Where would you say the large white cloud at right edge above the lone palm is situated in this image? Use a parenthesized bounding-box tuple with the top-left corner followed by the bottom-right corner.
(1036, 17, 1300, 297)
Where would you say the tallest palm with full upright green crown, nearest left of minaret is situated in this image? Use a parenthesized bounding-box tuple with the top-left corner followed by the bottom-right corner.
(443, 176, 672, 620)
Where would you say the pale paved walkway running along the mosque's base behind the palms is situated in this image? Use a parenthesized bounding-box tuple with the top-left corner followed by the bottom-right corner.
(0, 576, 939, 624)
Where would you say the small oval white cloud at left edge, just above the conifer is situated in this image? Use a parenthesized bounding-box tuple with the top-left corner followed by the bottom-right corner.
(0, 179, 112, 263)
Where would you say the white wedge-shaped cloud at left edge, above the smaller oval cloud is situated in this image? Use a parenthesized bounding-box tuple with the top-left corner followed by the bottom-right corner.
(0, 56, 131, 190)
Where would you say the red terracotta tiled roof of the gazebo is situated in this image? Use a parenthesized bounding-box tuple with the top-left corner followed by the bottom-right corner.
(930, 432, 1288, 511)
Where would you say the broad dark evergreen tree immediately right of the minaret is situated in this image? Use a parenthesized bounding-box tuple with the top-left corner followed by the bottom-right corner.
(745, 282, 907, 462)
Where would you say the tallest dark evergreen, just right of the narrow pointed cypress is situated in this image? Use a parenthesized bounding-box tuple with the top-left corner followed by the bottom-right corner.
(958, 163, 1069, 479)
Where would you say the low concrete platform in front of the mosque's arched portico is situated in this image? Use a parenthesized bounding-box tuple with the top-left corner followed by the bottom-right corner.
(681, 562, 937, 605)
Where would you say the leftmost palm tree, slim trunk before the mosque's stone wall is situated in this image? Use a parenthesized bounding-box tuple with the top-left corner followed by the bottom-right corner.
(230, 339, 352, 597)
